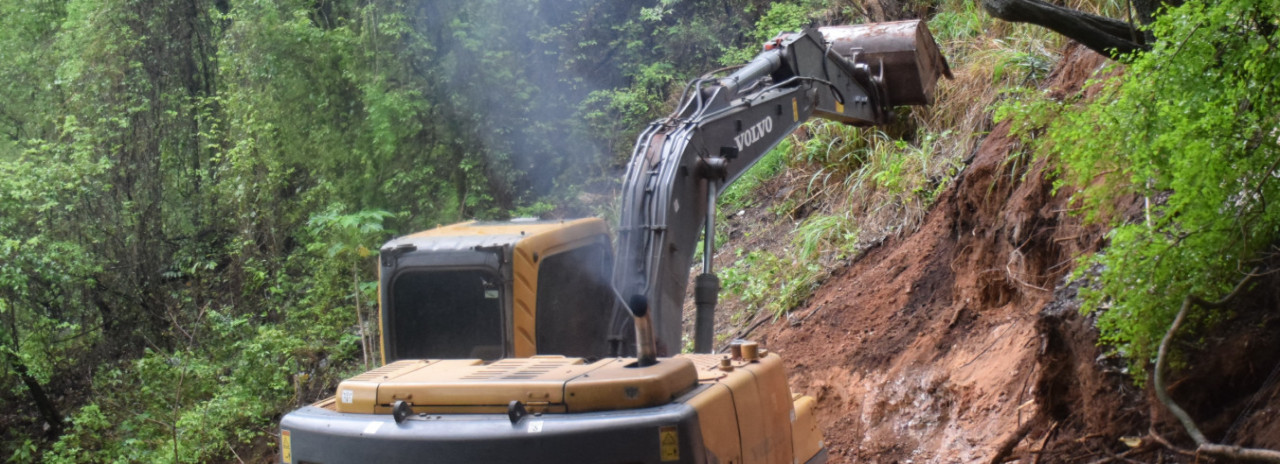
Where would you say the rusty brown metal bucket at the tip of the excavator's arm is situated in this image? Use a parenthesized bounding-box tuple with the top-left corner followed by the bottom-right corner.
(818, 19, 952, 106)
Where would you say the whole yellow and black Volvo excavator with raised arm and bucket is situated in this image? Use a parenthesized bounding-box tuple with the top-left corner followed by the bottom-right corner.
(279, 21, 951, 464)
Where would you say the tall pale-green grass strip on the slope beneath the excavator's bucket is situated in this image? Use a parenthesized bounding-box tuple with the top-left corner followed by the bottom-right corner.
(722, 0, 1064, 315)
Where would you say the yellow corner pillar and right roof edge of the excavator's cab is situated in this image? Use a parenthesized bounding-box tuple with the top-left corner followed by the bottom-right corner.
(512, 218, 609, 356)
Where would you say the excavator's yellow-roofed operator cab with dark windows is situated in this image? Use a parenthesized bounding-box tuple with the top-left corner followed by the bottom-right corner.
(379, 218, 620, 363)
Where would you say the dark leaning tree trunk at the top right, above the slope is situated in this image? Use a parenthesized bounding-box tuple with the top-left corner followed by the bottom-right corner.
(982, 0, 1148, 59)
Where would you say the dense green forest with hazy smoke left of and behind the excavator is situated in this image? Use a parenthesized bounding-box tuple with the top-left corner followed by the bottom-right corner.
(0, 0, 814, 461)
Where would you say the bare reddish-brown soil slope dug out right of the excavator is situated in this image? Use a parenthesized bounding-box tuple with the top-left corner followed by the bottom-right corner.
(721, 44, 1280, 463)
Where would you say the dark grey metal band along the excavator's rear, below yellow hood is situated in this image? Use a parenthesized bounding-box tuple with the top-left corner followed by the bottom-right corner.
(280, 402, 705, 464)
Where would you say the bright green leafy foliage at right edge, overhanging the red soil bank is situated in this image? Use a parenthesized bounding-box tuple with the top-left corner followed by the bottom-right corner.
(1048, 0, 1280, 378)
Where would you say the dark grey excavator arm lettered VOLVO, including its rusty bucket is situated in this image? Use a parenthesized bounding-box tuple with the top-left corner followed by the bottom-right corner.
(614, 21, 950, 364)
